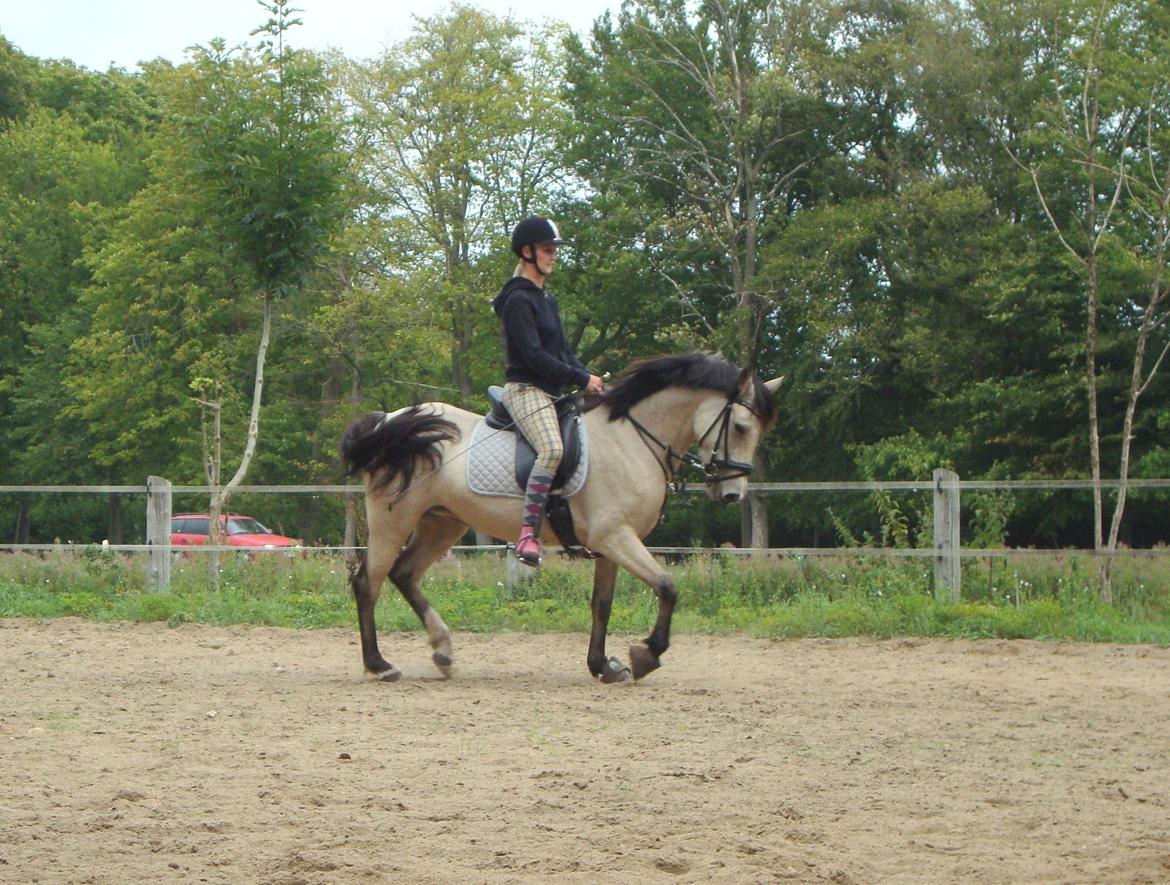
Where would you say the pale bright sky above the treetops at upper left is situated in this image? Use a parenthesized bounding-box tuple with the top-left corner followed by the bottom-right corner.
(0, 0, 621, 71)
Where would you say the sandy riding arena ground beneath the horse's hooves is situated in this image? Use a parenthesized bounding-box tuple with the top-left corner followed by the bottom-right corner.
(0, 619, 1170, 885)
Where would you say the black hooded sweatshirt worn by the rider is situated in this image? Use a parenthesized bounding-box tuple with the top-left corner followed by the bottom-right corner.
(491, 276, 591, 396)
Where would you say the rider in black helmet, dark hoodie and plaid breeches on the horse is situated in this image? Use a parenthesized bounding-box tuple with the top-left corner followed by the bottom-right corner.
(491, 215, 603, 565)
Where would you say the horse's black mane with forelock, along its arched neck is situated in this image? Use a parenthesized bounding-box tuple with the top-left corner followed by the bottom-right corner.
(600, 351, 776, 425)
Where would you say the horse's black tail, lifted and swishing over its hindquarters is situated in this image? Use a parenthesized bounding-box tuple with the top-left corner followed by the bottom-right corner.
(340, 405, 460, 500)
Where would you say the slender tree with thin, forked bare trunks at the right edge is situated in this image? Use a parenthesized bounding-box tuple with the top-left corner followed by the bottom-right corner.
(1005, 0, 1170, 602)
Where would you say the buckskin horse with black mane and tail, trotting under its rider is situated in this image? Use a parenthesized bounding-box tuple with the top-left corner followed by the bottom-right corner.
(340, 352, 783, 682)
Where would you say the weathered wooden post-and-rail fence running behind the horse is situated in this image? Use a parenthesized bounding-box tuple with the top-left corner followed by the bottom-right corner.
(0, 469, 1170, 601)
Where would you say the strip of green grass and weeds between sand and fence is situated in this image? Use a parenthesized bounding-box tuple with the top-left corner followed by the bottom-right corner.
(0, 550, 1170, 645)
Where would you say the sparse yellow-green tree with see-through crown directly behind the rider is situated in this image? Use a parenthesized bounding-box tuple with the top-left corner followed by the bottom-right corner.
(346, 4, 563, 397)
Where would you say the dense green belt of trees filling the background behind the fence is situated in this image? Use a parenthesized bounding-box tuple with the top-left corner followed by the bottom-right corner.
(0, 0, 1170, 546)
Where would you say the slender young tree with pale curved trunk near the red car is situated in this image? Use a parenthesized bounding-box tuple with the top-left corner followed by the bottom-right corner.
(177, 0, 343, 543)
